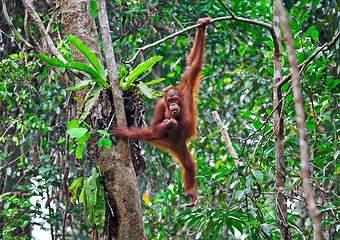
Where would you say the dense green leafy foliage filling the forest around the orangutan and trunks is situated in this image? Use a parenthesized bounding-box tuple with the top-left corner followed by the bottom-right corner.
(0, 0, 340, 239)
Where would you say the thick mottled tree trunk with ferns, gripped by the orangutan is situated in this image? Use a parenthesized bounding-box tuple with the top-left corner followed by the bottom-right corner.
(61, 0, 144, 240)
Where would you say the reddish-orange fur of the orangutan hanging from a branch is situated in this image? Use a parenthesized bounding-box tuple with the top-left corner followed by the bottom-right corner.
(115, 18, 210, 206)
